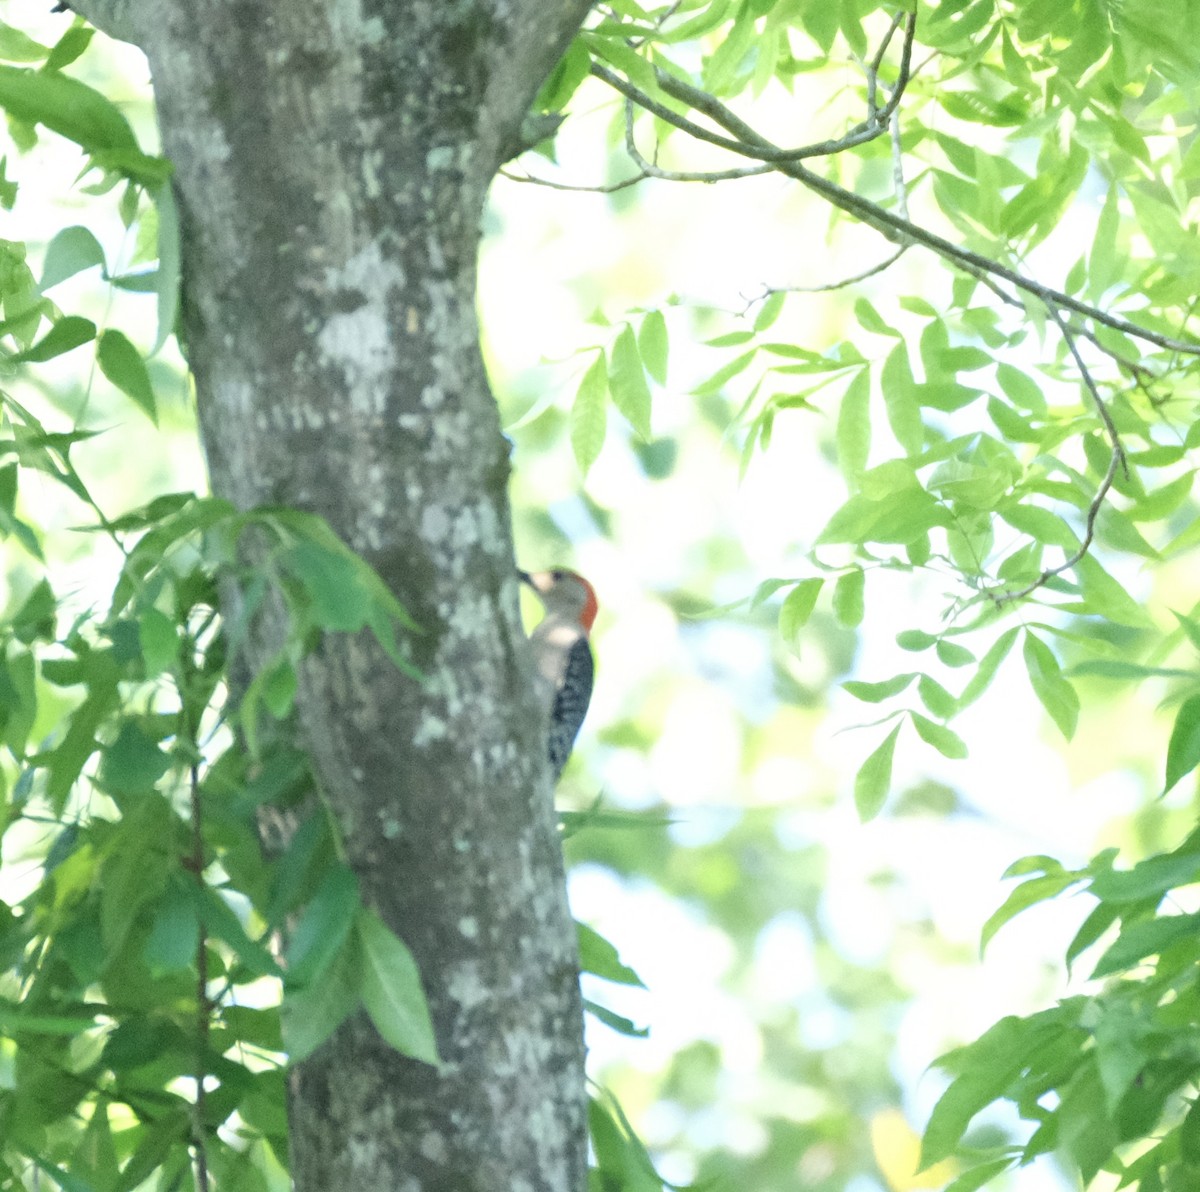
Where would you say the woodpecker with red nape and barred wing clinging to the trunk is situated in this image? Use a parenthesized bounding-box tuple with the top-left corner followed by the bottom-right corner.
(520, 568, 596, 781)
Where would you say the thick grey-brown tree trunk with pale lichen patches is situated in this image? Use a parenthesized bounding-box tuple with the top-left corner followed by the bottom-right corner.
(118, 0, 588, 1192)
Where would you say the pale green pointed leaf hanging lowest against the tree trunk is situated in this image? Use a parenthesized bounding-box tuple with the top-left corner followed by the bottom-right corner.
(358, 906, 440, 1066)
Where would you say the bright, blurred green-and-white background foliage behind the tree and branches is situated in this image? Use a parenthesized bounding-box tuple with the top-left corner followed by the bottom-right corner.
(0, 0, 1200, 1192)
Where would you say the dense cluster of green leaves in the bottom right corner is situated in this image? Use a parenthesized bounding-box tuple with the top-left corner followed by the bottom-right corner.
(922, 832, 1200, 1192)
